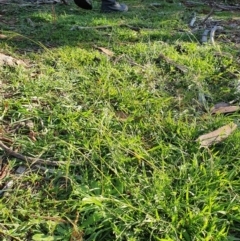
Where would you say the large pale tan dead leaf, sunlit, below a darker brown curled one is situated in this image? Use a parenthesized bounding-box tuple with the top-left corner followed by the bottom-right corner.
(197, 123, 237, 147)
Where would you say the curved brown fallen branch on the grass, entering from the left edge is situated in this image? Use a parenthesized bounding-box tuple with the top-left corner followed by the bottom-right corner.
(0, 141, 64, 166)
